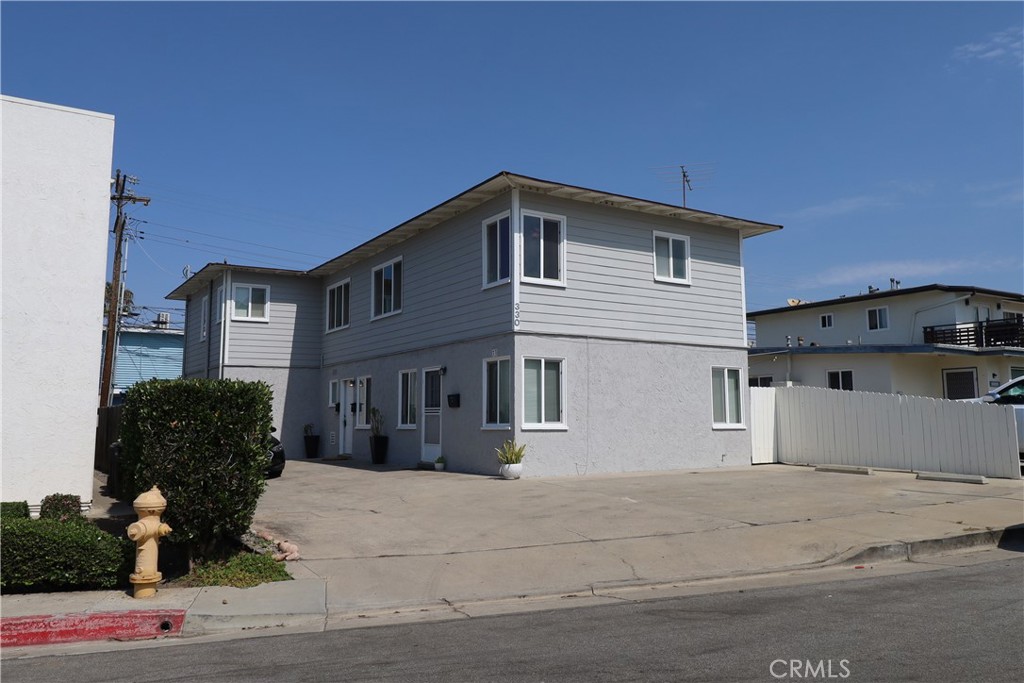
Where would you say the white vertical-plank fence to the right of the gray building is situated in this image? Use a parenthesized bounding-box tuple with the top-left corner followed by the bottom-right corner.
(751, 387, 1021, 479)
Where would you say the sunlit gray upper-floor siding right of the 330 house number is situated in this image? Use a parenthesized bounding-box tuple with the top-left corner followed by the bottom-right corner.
(519, 193, 744, 346)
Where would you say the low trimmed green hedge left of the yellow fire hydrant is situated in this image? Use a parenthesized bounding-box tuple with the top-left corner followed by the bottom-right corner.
(0, 517, 135, 593)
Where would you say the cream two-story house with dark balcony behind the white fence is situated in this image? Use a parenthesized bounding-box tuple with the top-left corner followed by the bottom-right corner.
(748, 285, 1024, 398)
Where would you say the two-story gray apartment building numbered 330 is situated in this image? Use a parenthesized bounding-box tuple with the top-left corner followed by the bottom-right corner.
(168, 172, 780, 475)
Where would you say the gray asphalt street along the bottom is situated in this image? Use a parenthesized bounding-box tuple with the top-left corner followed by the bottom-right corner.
(2, 549, 1024, 683)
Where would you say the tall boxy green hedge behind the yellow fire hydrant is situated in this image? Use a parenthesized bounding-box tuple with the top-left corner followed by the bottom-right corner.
(120, 380, 272, 558)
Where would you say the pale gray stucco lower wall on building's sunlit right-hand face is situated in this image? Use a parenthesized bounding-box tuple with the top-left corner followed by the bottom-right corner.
(515, 335, 751, 476)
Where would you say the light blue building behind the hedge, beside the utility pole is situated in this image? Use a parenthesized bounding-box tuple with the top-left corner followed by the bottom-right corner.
(100, 325, 185, 404)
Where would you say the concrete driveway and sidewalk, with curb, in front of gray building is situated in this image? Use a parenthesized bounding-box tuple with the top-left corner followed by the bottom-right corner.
(2, 461, 1024, 647)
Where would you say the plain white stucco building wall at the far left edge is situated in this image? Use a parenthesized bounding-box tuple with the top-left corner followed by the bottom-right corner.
(0, 96, 114, 513)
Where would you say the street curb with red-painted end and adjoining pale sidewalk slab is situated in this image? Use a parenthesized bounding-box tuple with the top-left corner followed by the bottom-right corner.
(0, 525, 1024, 647)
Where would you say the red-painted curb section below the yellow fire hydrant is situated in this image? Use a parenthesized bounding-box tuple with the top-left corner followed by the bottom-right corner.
(0, 609, 185, 647)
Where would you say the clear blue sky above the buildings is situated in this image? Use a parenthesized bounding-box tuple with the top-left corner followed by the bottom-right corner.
(0, 1, 1024, 327)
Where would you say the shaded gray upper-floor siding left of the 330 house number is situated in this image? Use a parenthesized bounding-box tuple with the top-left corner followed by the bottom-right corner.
(321, 195, 512, 365)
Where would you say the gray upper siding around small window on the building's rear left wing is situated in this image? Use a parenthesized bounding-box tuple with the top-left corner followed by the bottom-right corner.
(225, 272, 323, 368)
